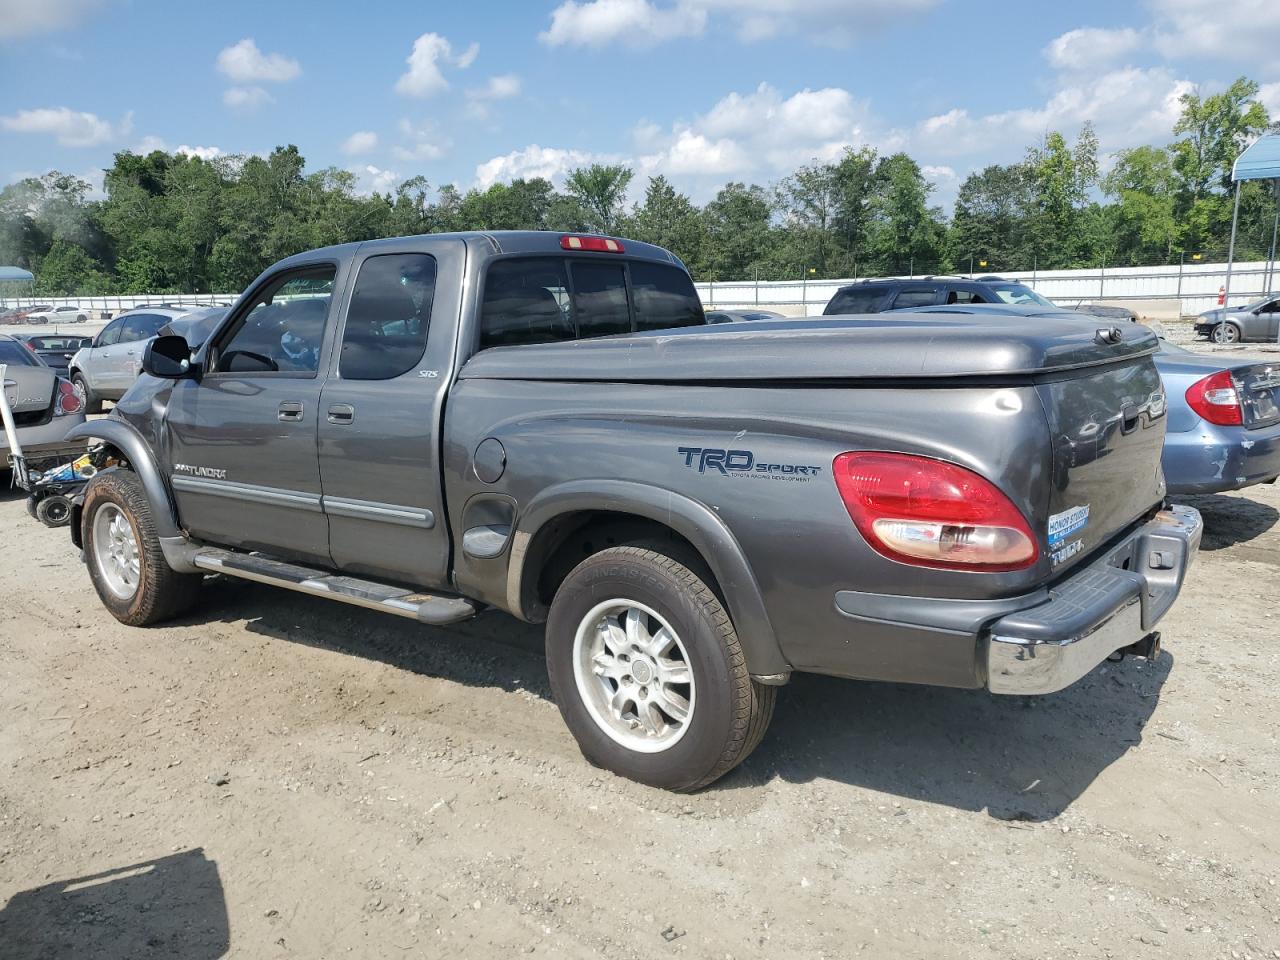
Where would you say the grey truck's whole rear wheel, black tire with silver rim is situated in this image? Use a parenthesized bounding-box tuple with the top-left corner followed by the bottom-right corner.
(547, 547, 777, 792)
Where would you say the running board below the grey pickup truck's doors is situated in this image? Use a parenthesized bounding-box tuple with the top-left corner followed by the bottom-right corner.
(191, 547, 481, 626)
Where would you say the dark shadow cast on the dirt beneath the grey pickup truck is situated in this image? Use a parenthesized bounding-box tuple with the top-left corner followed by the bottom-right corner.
(180, 579, 1174, 820)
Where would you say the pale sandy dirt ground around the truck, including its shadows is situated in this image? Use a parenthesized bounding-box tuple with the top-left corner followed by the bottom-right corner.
(0, 427, 1280, 960)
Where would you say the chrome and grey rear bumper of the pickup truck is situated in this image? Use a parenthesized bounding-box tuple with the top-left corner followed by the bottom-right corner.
(986, 507, 1203, 694)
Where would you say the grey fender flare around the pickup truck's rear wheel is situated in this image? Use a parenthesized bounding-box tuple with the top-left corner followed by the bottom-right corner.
(507, 480, 791, 682)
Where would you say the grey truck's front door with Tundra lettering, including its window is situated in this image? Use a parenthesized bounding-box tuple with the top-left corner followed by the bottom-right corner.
(165, 262, 342, 566)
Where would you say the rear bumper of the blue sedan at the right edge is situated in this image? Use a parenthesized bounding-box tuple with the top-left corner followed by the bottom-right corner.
(1161, 421, 1280, 495)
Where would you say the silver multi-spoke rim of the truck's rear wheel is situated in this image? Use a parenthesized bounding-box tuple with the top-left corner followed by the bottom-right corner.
(573, 599, 696, 754)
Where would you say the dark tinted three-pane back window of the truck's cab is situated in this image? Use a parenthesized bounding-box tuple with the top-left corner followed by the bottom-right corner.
(480, 256, 708, 349)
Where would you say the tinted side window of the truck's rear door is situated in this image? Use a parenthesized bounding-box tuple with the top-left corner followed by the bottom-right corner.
(338, 253, 435, 380)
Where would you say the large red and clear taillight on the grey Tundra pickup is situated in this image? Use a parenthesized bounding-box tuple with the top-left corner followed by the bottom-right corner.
(832, 451, 1039, 572)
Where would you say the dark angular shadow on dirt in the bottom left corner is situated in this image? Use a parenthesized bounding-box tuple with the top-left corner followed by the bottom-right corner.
(0, 849, 230, 960)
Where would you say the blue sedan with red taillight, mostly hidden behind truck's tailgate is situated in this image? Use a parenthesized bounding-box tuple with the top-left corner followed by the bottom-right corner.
(895, 305, 1280, 495)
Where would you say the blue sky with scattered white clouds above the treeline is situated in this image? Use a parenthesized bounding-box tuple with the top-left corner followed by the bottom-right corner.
(0, 0, 1280, 204)
